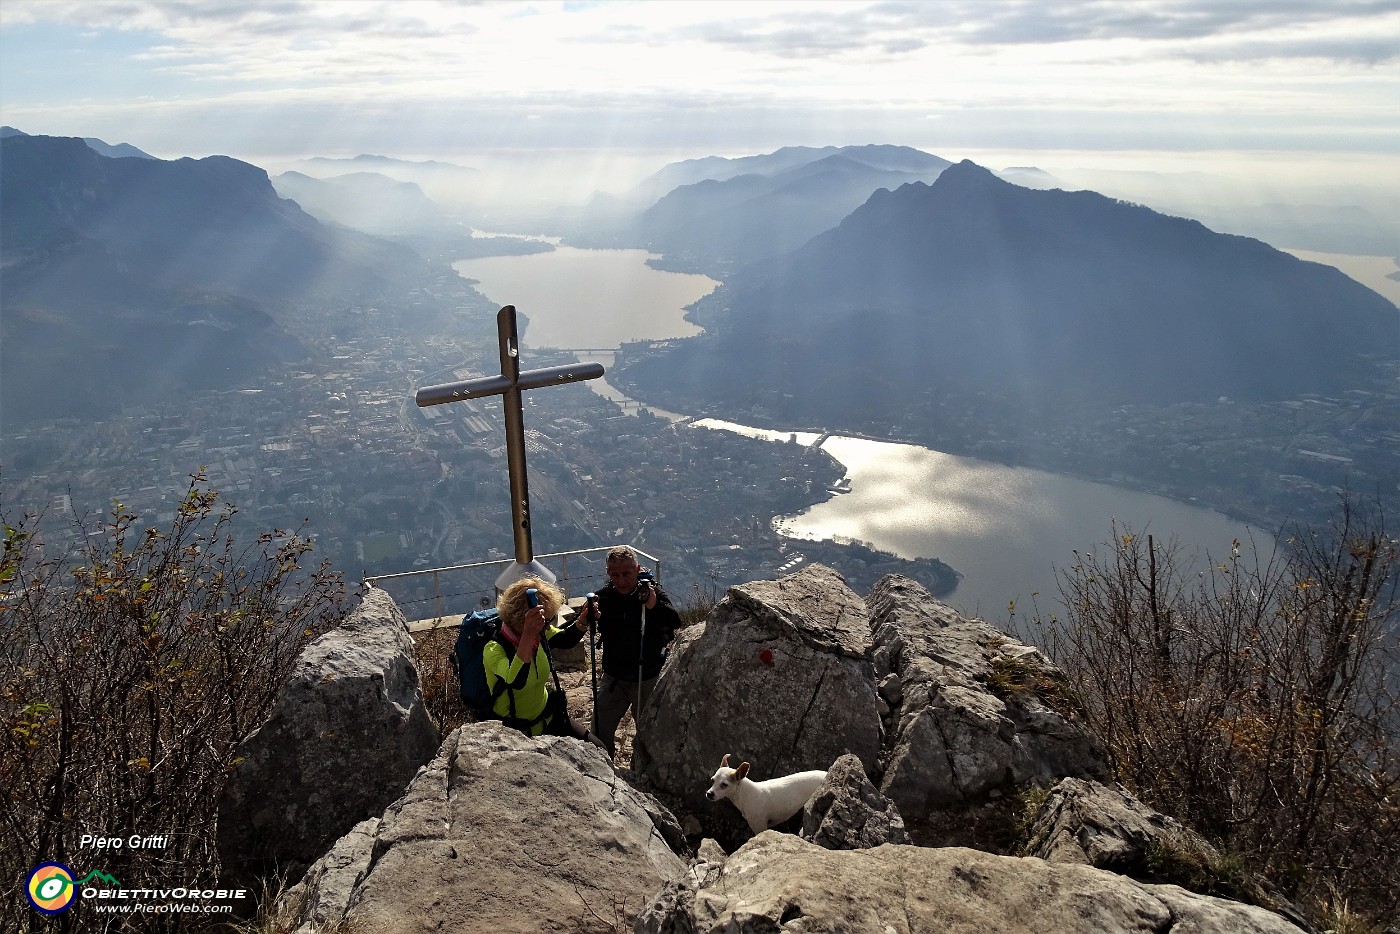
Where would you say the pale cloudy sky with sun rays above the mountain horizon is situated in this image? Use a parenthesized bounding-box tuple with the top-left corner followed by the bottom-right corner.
(0, 0, 1400, 190)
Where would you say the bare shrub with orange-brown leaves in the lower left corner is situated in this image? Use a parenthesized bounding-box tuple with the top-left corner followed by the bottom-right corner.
(0, 475, 344, 930)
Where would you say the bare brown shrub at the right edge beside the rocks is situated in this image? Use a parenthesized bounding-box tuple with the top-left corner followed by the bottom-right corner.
(1033, 497, 1400, 919)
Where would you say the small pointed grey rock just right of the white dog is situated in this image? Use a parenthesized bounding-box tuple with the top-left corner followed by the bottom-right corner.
(801, 755, 910, 850)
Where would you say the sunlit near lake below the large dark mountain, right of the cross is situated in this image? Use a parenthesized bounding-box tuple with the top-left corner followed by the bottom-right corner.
(696, 419, 1268, 620)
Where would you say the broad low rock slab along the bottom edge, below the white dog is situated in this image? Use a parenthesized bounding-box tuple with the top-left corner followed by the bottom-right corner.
(634, 830, 1299, 934)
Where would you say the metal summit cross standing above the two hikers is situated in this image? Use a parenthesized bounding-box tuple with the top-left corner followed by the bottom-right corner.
(414, 305, 603, 590)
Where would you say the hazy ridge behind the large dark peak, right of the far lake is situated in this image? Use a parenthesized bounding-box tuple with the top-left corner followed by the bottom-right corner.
(633, 146, 951, 263)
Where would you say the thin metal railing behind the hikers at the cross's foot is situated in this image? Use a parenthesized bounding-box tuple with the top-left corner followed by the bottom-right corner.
(364, 546, 662, 620)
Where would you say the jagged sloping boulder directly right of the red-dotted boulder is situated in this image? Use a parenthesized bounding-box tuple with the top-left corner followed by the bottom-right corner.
(865, 574, 1110, 819)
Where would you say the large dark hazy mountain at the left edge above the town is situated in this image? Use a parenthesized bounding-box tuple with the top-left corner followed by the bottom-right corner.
(0, 134, 419, 421)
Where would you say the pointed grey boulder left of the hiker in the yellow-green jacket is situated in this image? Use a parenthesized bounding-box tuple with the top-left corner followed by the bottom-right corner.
(218, 590, 440, 879)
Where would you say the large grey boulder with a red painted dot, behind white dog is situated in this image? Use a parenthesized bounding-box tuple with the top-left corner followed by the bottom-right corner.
(633, 564, 881, 812)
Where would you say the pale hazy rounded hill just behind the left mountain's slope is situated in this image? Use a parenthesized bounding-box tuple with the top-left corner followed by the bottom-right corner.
(272, 172, 448, 234)
